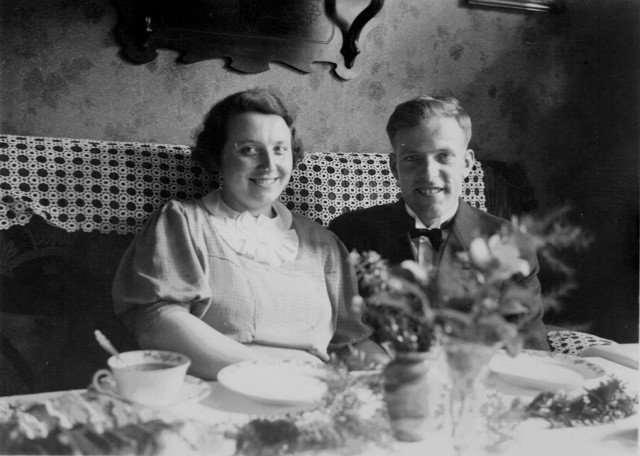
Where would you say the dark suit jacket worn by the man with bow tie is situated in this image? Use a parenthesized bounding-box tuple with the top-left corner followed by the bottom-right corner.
(329, 199, 549, 350)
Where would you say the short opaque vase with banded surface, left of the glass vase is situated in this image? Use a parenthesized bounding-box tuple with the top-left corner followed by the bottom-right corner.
(382, 351, 444, 442)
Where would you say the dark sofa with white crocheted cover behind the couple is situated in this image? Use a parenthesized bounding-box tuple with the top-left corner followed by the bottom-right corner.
(0, 135, 610, 395)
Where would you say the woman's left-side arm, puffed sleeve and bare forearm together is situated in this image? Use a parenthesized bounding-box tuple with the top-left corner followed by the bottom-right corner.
(113, 202, 268, 379)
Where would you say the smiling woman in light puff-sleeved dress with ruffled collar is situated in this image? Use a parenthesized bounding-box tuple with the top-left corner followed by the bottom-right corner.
(113, 89, 384, 379)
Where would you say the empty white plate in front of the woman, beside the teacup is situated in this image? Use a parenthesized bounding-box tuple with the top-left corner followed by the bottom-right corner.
(218, 361, 327, 405)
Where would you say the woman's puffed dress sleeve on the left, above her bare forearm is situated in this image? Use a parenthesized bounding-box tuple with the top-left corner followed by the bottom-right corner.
(112, 201, 211, 336)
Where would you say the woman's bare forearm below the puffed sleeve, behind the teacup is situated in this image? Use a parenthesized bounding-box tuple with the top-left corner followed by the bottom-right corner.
(138, 310, 273, 380)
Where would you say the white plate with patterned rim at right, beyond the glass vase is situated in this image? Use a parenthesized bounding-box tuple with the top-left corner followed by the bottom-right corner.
(489, 351, 605, 391)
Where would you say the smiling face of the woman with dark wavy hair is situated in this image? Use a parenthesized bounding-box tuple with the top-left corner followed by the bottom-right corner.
(220, 112, 293, 217)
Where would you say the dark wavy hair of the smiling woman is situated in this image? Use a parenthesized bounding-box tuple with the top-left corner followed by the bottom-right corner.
(193, 88, 304, 173)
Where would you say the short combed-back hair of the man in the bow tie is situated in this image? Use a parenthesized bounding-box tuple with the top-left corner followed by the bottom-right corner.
(387, 96, 471, 144)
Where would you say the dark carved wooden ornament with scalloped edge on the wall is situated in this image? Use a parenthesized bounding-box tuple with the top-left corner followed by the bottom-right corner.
(111, 0, 384, 79)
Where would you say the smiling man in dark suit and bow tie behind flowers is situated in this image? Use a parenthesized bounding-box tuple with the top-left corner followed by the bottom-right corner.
(329, 97, 549, 350)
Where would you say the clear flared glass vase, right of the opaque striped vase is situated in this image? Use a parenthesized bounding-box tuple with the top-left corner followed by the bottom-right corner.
(443, 338, 497, 455)
